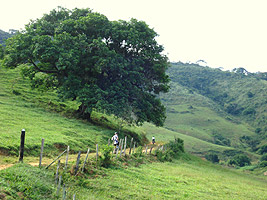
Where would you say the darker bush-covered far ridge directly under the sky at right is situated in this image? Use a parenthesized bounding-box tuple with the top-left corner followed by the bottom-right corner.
(169, 63, 267, 134)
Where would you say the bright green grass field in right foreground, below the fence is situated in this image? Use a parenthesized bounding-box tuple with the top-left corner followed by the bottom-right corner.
(68, 154, 267, 200)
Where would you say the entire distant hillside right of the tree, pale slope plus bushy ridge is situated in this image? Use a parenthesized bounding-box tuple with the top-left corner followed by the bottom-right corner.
(157, 63, 267, 158)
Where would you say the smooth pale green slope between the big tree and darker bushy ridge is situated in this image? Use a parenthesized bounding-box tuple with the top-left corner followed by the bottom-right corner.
(154, 65, 264, 158)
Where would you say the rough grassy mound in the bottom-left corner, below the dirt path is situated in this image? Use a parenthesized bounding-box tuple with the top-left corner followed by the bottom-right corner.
(0, 164, 55, 200)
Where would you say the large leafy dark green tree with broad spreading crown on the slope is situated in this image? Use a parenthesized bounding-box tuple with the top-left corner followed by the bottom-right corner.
(5, 7, 169, 125)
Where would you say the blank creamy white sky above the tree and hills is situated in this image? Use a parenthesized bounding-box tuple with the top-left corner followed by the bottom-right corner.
(0, 0, 267, 72)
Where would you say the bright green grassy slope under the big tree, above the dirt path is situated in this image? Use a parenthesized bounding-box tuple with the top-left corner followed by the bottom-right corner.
(0, 64, 144, 155)
